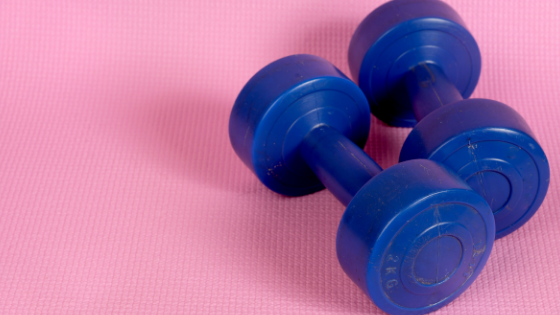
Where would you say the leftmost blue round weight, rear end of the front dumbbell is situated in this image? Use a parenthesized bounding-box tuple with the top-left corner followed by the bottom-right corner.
(229, 55, 371, 196)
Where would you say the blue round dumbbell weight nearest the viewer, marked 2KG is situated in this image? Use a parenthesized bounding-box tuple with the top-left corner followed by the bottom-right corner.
(337, 160, 495, 314)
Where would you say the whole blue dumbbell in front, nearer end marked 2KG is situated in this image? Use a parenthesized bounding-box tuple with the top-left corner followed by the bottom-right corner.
(229, 55, 495, 314)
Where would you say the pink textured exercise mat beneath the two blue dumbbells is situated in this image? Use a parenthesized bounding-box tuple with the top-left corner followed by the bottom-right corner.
(0, 0, 560, 314)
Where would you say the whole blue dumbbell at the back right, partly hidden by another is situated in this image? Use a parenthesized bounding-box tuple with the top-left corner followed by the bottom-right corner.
(348, 0, 550, 238)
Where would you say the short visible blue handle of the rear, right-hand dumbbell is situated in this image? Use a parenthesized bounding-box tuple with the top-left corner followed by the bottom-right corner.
(404, 63, 463, 121)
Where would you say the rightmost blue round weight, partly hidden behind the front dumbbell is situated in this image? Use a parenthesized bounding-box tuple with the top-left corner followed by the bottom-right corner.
(400, 99, 550, 238)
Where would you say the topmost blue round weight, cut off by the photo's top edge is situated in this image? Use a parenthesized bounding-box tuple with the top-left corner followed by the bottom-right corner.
(348, 0, 481, 127)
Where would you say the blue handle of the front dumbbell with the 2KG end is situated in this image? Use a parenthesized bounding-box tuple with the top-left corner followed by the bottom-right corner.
(300, 125, 383, 206)
